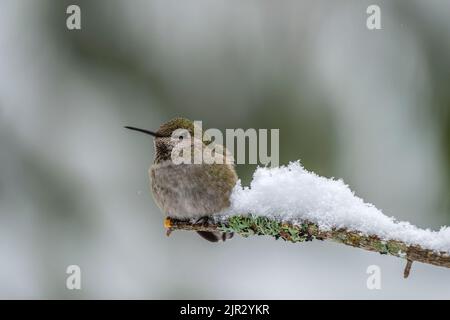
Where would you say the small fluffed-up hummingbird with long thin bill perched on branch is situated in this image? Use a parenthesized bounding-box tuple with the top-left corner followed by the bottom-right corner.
(125, 118, 238, 242)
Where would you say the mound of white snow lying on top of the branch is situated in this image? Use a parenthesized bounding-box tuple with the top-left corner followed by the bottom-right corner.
(222, 162, 450, 253)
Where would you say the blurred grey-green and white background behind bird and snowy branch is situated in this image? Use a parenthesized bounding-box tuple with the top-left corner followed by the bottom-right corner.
(0, 0, 450, 299)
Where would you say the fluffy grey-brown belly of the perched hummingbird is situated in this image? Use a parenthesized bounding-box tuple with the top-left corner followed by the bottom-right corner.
(149, 164, 231, 219)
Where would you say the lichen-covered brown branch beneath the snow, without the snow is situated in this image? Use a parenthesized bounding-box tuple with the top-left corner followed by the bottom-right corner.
(164, 216, 450, 277)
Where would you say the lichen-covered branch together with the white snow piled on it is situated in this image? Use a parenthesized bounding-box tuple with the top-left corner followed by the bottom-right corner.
(166, 162, 450, 277)
